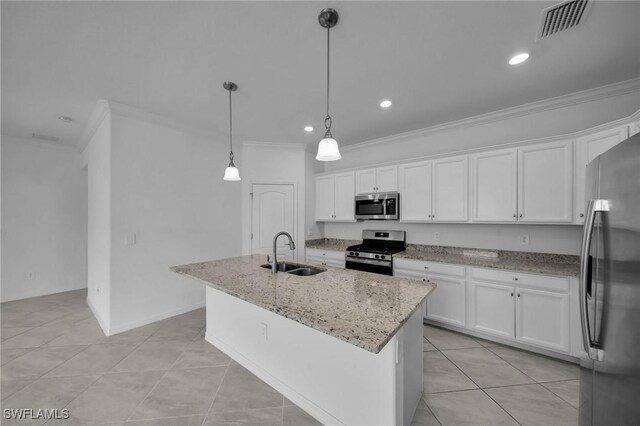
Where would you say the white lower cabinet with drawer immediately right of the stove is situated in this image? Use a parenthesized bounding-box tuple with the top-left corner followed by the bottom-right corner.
(393, 258, 466, 327)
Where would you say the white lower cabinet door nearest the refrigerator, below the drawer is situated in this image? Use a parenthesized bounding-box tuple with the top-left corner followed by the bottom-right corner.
(516, 288, 570, 353)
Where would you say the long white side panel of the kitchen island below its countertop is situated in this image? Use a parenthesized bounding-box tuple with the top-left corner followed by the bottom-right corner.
(205, 287, 402, 425)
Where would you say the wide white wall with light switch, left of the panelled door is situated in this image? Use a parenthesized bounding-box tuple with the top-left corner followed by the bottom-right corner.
(81, 101, 241, 334)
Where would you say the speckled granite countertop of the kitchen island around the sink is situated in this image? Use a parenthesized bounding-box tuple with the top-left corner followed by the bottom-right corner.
(171, 255, 436, 353)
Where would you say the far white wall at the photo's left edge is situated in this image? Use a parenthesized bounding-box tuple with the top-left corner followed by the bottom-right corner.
(1, 135, 87, 302)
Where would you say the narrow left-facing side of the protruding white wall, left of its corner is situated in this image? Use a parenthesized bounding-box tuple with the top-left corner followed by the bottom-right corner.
(83, 114, 111, 331)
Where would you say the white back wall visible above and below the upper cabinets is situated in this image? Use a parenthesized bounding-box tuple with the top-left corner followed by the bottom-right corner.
(322, 80, 640, 255)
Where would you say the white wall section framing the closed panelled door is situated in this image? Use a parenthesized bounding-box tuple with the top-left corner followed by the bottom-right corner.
(241, 142, 308, 256)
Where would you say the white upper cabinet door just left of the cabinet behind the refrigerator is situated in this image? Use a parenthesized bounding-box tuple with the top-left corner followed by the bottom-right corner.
(518, 141, 573, 222)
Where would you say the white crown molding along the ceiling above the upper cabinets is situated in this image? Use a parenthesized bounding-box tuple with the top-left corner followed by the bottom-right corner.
(341, 78, 640, 152)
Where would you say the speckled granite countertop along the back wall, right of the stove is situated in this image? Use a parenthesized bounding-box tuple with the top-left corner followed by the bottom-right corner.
(394, 244, 580, 277)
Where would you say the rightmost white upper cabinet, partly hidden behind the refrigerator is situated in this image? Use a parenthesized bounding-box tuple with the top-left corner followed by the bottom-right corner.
(574, 125, 628, 223)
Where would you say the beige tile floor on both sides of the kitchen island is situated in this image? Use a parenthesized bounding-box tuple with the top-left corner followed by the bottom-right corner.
(0, 290, 579, 426)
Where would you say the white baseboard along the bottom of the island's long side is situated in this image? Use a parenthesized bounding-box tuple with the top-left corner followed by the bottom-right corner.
(204, 333, 344, 425)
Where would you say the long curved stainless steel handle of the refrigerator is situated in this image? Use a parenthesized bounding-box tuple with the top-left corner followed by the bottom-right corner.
(579, 200, 609, 360)
